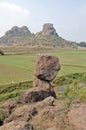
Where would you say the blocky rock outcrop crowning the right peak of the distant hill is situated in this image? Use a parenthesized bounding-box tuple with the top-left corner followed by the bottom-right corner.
(42, 23, 58, 36)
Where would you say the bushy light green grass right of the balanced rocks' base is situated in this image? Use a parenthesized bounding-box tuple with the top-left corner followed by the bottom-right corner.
(57, 81, 86, 103)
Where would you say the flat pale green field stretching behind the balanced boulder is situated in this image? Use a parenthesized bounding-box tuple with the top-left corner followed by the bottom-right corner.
(0, 50, 86, 84)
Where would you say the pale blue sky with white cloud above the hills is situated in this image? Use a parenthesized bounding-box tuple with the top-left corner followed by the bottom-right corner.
(0, 0, 86, 42)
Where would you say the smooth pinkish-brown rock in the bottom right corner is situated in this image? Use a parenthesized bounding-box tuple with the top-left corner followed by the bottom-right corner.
(68, 102, 86, 130)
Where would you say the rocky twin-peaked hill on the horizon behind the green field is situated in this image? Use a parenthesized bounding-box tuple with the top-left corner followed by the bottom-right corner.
(0, 23, 77, 48)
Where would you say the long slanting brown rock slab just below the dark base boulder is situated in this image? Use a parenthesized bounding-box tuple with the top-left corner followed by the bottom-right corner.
(4, 96, 54, 123)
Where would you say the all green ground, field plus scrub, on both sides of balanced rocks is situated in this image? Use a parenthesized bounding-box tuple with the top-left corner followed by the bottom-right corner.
(0, 50, 86, 102)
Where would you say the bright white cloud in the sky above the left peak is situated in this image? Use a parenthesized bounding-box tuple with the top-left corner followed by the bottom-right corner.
(0, 3, 30, 35)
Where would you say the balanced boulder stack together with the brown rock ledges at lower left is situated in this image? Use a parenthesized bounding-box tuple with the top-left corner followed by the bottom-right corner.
(0, 54, 60, 130)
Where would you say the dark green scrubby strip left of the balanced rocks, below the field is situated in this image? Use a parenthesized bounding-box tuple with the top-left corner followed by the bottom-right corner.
(0, 81, 32, 102)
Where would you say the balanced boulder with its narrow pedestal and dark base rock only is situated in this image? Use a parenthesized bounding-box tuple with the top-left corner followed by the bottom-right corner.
(18, 54, 60, 103)
